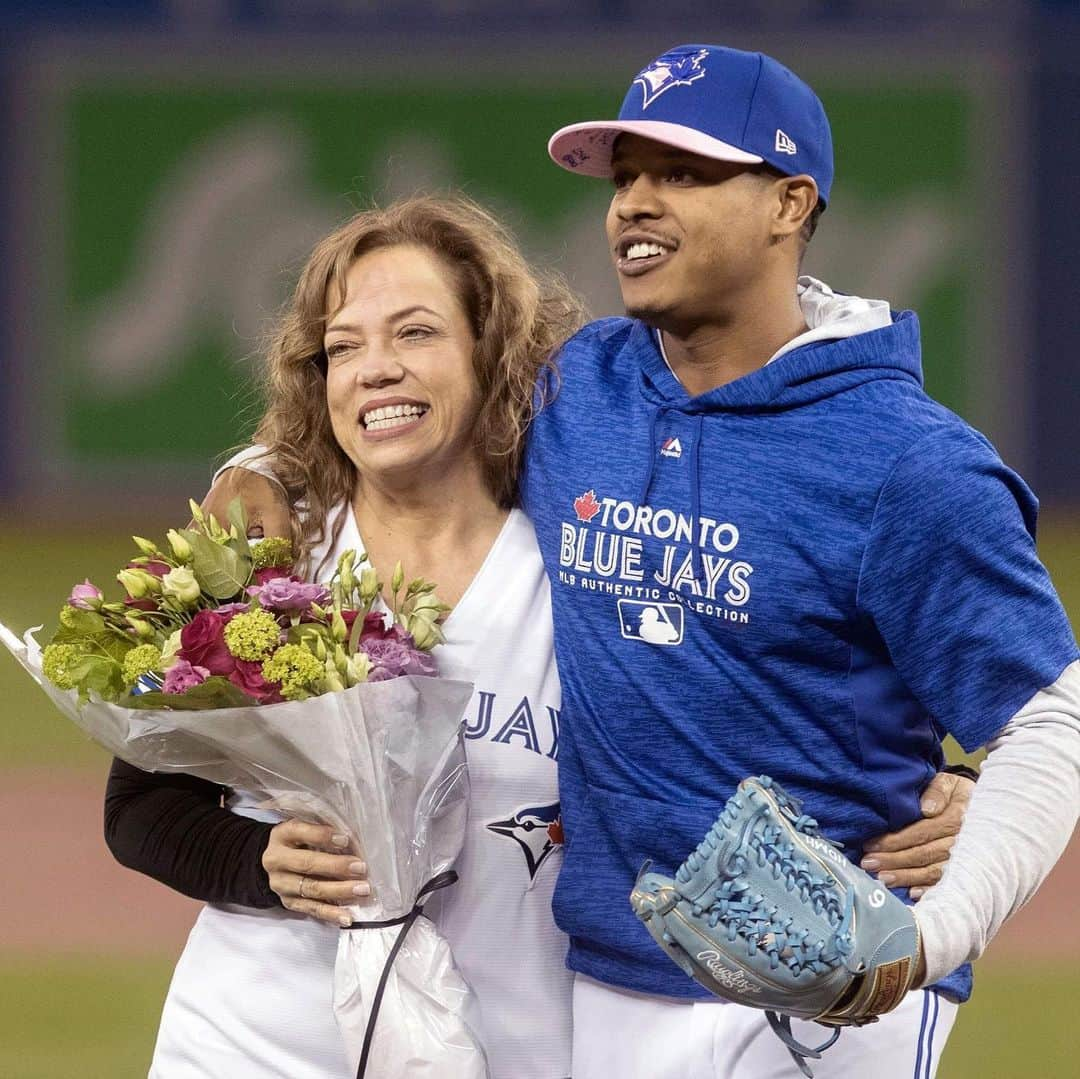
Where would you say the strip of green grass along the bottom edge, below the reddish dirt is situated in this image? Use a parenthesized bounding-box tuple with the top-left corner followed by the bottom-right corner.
(0, 959, 1080, 1079)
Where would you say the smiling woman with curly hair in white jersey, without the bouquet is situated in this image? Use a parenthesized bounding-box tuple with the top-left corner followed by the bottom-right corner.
(106, 198, 583, 1079)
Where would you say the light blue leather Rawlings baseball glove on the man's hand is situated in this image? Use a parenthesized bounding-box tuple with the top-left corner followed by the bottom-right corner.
(630, 775, 919, 1076)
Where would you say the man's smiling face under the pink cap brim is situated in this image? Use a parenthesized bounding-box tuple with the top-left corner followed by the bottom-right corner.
(607, 134, 778, 336)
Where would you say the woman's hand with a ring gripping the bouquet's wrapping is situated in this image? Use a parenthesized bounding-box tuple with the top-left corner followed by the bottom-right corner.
(262, 820, 372, 926)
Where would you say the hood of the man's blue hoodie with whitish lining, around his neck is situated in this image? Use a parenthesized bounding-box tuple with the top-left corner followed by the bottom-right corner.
(627, 277, 922, 415)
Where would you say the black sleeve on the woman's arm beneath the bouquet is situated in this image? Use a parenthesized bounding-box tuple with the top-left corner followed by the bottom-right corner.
(105, 760, 281, 907)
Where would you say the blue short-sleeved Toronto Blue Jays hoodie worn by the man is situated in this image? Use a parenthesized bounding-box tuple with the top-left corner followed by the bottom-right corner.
(523, 312, 1077, 998)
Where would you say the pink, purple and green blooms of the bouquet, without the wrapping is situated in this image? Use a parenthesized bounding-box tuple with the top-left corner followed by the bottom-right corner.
(36, 502, 448, 709)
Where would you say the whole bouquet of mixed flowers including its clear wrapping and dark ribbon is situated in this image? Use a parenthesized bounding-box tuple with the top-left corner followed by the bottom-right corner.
(0, 503, 487, 1079)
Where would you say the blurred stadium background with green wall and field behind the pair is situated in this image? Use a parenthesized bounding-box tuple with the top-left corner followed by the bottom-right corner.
(0, 0, 1080, 1079)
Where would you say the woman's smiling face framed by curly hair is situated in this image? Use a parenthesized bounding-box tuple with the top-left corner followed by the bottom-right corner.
(323, 245, 481, 484)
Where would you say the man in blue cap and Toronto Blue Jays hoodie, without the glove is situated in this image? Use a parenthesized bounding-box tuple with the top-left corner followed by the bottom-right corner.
(531, 45, 1080, 1079)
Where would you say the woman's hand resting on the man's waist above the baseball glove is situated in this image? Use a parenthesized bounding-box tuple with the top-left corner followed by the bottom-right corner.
(859, 772, 975, 900)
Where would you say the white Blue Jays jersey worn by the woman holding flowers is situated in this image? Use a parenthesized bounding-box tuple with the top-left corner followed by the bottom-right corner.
(150, 507, 571, 1079)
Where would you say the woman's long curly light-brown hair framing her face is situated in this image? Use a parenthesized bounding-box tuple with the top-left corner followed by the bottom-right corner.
(254, 195, 586, 559)
